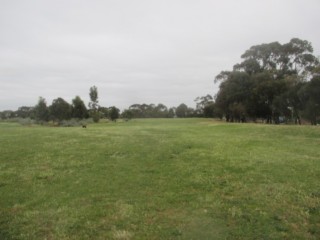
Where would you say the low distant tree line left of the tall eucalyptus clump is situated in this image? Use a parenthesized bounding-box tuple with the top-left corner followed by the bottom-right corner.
(0, 86, 213, 123)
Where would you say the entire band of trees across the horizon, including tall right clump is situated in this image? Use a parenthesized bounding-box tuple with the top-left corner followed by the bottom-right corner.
(0, 38, 320, 125)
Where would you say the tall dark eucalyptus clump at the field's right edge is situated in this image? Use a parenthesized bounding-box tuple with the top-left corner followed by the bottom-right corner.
(214, 38, 320, 124)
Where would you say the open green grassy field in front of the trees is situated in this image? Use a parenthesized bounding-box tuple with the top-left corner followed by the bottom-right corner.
(0, 119, 320, 240)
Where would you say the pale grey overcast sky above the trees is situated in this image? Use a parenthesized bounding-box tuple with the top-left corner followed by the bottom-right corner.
(0, 0, 320, 111)
